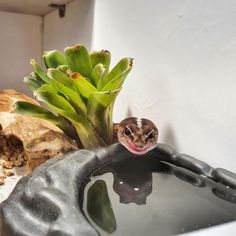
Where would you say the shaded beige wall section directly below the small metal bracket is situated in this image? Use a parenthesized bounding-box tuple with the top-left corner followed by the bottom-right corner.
(43, 0, 94, 52)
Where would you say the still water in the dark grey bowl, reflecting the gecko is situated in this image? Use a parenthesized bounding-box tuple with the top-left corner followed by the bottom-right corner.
(83, 158, 236, 236)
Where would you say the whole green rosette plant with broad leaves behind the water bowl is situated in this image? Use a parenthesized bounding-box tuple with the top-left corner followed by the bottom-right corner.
(15, 45, 132, 148)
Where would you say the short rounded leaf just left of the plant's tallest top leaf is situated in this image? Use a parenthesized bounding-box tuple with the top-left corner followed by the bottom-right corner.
(43, 50, 67, 68)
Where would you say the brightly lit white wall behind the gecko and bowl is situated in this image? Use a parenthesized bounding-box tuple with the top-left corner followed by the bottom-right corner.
(93, 0, 236, 171)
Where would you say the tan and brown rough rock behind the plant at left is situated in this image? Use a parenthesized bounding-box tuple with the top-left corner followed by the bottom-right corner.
(0, 90, 77, 170)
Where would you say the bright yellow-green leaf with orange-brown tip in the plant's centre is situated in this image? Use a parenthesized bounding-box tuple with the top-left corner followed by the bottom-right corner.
(71, 73, 97, 99)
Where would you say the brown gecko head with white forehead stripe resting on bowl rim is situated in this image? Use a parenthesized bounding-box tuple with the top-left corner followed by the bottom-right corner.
(117, 117, 158, 155)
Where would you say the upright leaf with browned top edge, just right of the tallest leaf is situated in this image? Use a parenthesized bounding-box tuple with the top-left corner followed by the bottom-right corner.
(90, 50, 111, 75)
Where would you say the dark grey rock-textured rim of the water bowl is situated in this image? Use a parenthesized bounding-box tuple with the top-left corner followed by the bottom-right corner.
(0, 144, 236, 236)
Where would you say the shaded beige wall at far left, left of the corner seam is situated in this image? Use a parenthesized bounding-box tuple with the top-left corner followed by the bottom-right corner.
(0, 12, 42, 94)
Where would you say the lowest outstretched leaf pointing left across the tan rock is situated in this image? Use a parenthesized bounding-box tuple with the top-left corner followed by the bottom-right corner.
(14, 101, 59, 124)
